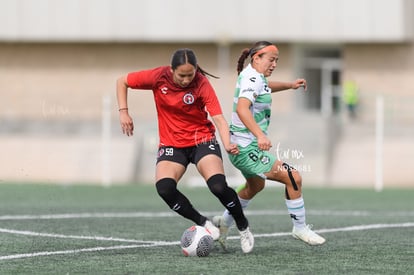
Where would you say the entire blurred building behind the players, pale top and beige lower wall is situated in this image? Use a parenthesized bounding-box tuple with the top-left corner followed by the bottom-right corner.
(0, 0, 414, 189)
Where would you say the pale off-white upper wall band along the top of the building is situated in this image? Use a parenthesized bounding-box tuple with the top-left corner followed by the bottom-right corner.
(0, 0, 414, 43)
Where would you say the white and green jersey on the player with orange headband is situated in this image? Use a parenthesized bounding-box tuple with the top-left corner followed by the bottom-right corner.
(230, 64, 272, 147)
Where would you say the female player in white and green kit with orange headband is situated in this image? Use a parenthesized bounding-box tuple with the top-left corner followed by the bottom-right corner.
(213, 41, 325, 249)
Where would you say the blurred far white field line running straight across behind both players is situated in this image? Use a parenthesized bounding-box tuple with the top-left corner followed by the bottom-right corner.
(0, 210, 414, 220)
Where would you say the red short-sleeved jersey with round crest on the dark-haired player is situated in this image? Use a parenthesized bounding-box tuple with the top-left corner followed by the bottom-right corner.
(127, 66, 222, 148)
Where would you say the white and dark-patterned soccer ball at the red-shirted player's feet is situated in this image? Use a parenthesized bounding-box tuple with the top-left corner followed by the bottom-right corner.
(180, 225, 214, 257)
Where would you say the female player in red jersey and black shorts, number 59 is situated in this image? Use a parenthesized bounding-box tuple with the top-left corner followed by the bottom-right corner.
(117, 49, 254, 253)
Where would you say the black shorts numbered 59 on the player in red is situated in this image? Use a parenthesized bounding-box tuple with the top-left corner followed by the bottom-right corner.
(157, 139, 222, 167)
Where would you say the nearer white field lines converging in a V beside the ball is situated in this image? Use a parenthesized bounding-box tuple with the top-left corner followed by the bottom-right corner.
(0, 222, 414, 261)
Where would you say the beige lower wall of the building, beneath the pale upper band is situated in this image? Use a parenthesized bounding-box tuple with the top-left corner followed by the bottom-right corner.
(0, 43, 414, 186)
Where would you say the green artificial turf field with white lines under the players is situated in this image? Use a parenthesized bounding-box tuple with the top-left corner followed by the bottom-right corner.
(0, 183, 414, 275)
